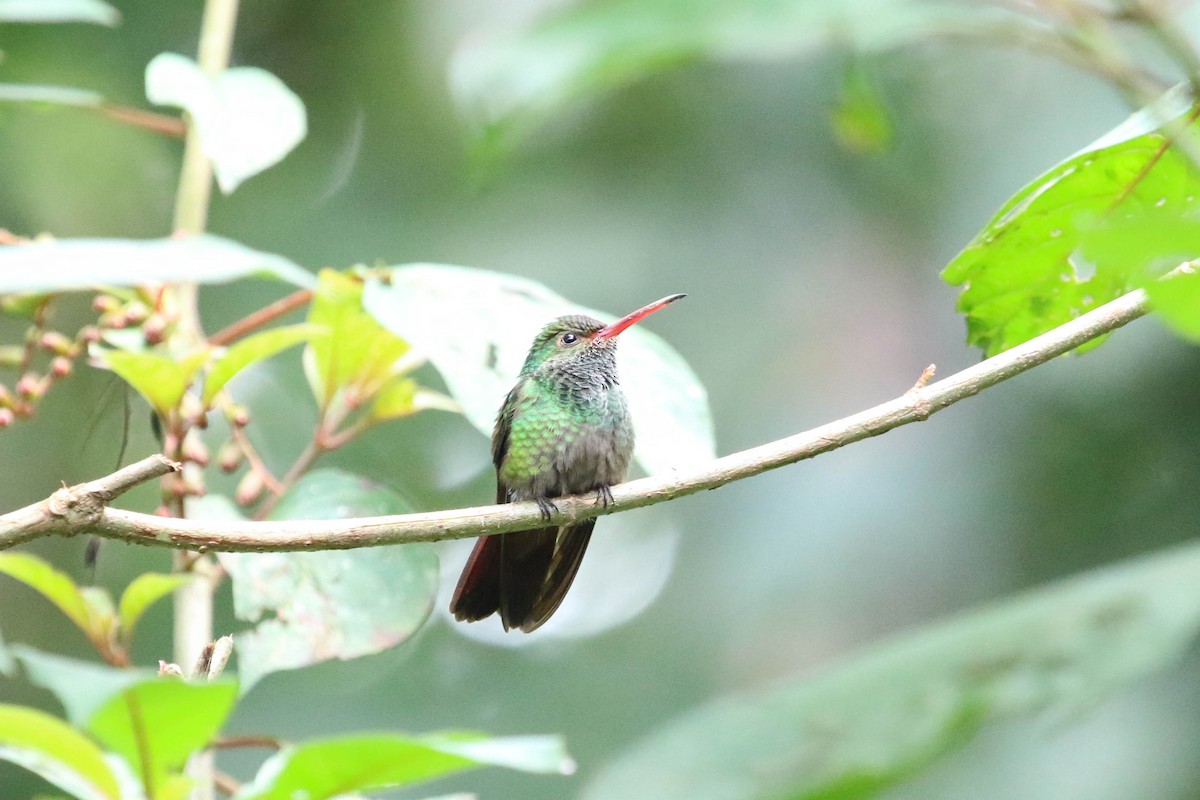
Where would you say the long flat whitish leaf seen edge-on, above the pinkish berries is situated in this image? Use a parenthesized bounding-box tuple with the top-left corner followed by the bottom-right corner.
(0, 234, 313, 294)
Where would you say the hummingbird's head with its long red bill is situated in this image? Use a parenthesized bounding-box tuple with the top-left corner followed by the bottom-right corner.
(521, 294, 686, 379)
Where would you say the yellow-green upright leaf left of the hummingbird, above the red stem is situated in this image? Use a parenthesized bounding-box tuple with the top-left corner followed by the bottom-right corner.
(305, 270, 409, 408)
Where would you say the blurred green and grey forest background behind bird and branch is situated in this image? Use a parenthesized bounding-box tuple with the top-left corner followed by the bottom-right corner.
(0, 0, 1200, 800)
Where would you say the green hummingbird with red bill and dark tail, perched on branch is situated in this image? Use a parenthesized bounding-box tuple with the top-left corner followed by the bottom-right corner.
(450, 294, 685, 632)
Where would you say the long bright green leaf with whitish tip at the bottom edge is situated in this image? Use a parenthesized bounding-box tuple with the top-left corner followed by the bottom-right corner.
(235, 734, 576, 800)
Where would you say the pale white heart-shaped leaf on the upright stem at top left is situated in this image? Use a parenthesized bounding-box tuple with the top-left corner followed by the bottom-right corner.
(146, 53, 307, 194)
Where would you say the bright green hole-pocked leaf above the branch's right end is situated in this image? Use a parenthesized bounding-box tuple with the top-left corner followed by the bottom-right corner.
(942, 98, 1200, 355)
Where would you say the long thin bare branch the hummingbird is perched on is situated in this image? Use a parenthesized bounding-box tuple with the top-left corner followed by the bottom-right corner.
(0, 289, 1147, 552)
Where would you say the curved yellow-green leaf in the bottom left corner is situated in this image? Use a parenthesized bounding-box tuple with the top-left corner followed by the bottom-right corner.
(0, 705, 121, 800)
